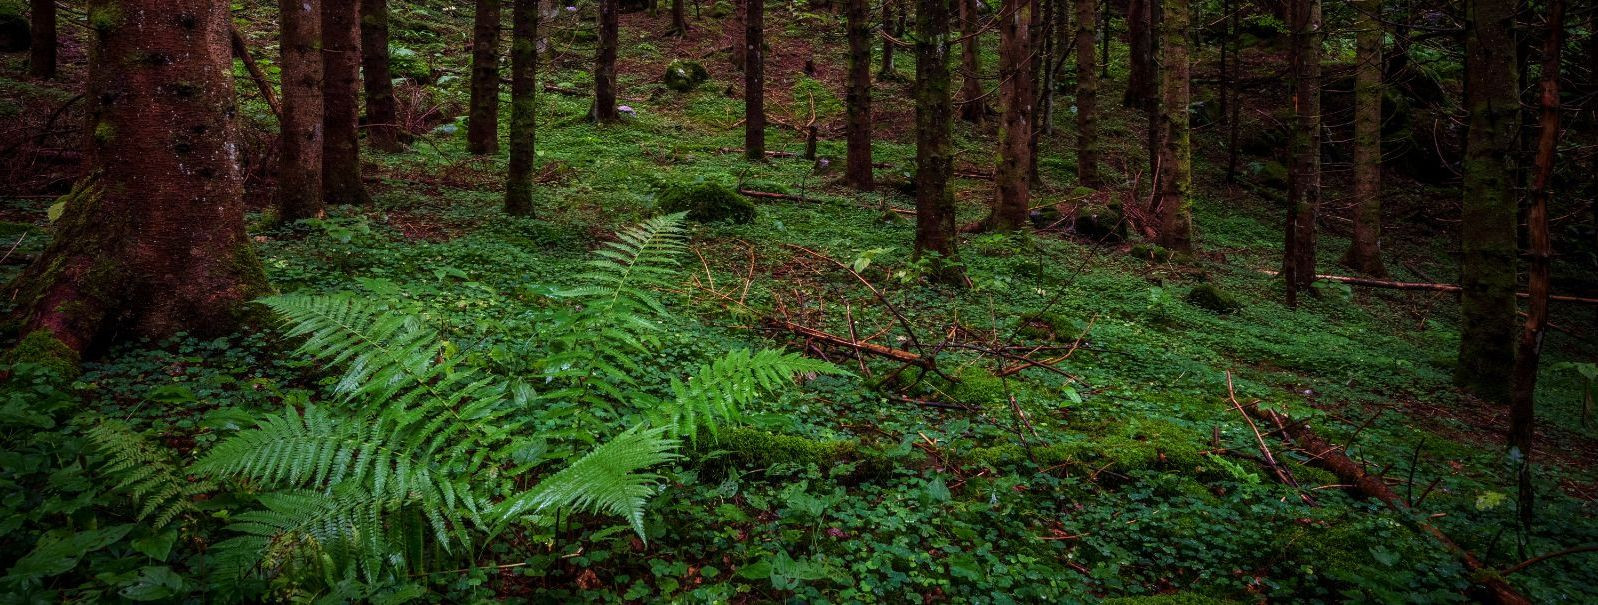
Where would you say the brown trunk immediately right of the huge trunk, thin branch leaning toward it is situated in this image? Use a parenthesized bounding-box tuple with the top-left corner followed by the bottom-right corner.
(278, 0, 323, 222)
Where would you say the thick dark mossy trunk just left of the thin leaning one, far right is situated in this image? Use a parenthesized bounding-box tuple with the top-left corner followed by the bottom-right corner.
(1454, 0, 1520, 402)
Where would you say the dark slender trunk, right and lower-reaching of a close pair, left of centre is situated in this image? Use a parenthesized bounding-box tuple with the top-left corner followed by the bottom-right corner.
(505, 0, 539, 216)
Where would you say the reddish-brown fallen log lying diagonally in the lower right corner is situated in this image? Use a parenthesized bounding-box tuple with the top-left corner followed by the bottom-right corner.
(1243, 404, 1531, 605)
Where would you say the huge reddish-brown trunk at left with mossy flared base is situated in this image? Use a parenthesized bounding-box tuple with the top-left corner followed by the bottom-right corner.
(8, 0, 267, 362)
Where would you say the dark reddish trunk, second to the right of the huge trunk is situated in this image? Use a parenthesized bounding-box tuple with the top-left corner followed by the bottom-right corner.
(321, 0, 371, 204)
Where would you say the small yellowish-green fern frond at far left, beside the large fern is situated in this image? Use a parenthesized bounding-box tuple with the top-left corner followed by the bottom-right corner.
(88, 420, 216, 528)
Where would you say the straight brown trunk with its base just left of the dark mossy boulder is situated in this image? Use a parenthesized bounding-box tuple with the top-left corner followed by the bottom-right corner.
(984, 0, 1036, 231)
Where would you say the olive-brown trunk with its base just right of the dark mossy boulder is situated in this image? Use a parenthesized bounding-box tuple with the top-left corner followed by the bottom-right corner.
(1159, 0, 1194, 255)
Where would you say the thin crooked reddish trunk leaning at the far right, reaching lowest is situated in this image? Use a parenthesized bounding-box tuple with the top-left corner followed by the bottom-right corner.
(1509, 0, 1564, 545)
